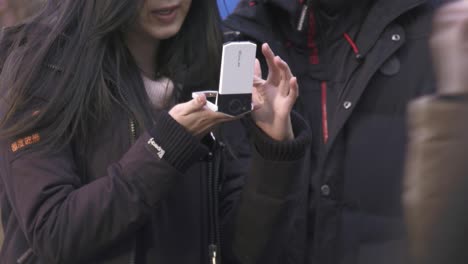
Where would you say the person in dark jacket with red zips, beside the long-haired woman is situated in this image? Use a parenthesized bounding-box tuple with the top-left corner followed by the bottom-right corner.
(225, 0, 434, 264)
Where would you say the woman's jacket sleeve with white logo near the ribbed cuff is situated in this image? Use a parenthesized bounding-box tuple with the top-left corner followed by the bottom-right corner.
(0, 111, 207, 264)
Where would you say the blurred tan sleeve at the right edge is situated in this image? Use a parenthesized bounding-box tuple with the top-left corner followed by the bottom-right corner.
(404, 95, 468, 263)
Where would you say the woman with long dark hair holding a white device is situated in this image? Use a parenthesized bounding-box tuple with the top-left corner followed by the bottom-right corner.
(0, 0, 309, 264)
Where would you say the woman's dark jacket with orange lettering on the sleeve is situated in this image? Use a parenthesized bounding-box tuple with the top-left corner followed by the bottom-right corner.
(0, 35, 310, 264)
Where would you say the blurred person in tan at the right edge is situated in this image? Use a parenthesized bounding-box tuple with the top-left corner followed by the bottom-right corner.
(404, 0, 468, 264)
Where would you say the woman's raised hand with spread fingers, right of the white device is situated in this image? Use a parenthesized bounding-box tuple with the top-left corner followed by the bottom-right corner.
(252, 44, 299, 141)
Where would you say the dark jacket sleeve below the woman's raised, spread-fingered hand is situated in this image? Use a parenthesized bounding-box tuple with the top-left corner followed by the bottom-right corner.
(221, 113, 311, 264)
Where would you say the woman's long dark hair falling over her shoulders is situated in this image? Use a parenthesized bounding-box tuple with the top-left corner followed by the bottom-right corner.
(0, 0, 222, 152)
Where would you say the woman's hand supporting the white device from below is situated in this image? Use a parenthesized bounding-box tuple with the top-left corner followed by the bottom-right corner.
(169, 95, 235, 138)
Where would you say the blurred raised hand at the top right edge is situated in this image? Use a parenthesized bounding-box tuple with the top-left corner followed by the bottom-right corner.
(431, 0, 468, 94)
